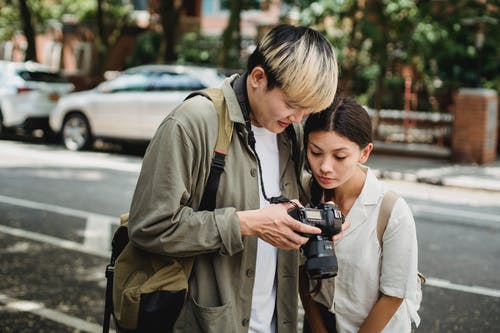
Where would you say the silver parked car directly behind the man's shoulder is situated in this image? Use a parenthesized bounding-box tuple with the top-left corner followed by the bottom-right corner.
(50, 65, 224, 150)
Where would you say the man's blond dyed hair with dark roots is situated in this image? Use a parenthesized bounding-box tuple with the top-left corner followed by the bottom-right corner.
(247, 24, 338, 111)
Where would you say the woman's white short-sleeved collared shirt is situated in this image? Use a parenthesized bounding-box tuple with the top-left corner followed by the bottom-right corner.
(318, 166, 418, 333)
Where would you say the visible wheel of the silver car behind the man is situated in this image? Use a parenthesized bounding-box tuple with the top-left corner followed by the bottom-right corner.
(62, 113, 92, 151)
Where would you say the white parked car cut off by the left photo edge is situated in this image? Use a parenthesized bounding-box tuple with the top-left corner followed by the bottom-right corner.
(0, 61, 74, 136)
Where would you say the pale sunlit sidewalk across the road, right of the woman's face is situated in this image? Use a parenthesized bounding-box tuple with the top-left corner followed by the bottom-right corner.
(366, 146, 500, 192)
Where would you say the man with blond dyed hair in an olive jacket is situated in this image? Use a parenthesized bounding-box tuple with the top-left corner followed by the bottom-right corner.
(129, 25, 338, 333)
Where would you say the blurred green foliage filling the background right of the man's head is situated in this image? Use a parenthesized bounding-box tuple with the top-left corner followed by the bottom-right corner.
(285, 0, 500, 109)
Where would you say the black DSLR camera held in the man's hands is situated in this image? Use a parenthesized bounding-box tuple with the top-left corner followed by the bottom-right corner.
(288, 204, 344, 280)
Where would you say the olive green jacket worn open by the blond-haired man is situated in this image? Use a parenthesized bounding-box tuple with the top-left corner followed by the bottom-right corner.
(129, 76, 302, 333)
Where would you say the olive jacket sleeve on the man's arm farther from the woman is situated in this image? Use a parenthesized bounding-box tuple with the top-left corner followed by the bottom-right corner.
(129, 102, 243, 257)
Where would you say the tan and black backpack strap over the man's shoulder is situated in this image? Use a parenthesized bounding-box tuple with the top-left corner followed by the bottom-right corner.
(186, 88, 234, 210)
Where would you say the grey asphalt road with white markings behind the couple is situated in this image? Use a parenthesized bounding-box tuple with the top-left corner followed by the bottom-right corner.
(0, 141, 500, 333)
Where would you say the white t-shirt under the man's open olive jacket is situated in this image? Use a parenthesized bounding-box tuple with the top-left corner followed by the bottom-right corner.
(248, 126, 281, 333)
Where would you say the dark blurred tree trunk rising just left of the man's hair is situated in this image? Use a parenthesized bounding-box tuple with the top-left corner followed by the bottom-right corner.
(219, 1, 243, 68)
